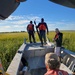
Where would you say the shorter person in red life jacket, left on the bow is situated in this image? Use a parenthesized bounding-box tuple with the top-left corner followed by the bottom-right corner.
(27, 21, 36, 43)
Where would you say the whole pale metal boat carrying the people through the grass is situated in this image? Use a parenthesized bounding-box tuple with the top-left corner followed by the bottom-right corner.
(6, 42, 75, 75)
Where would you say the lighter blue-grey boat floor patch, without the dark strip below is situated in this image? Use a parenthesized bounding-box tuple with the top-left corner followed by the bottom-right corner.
(27, 56, 45, 70)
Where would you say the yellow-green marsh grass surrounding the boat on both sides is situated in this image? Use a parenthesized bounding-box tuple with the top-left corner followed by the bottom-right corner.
(0, 31, 75, 71)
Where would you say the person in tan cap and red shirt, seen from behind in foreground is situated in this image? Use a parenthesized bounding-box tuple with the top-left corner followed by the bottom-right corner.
(44, 53, 69, 75)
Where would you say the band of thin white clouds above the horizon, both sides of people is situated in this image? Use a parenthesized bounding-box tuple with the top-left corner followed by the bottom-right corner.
(0, 15, 75, 32)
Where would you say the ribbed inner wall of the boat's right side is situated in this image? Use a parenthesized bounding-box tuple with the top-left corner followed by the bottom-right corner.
(61, 48, 75, 72)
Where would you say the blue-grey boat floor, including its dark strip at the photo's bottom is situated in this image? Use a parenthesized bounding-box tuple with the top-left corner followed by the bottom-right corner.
(27, 56, 46, 75)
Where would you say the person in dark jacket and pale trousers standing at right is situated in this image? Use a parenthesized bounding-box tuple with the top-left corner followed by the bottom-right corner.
(54, 28, 63, 61)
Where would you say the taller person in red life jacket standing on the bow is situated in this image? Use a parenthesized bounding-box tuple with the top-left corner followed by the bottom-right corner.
(37, 18, 48, 47)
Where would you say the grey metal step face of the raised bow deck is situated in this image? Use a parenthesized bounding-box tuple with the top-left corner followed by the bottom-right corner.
(23, 46, 54, 58)
